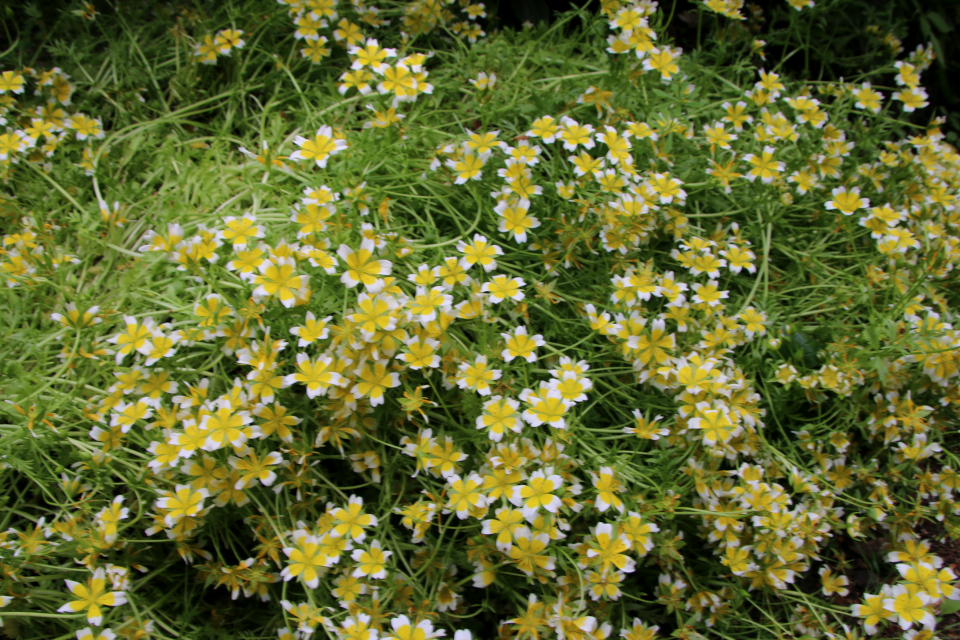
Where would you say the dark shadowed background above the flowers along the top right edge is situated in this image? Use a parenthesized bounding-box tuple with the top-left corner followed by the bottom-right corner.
(496, 0, 960, 144)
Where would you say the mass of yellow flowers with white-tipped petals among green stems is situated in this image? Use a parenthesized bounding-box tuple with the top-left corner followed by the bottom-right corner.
(0, 0, 960, 640)
